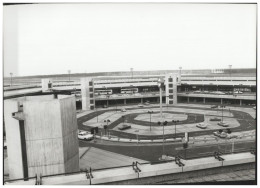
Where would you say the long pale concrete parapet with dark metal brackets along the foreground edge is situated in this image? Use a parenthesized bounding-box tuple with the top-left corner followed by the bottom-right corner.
(4, 152, 256, 185)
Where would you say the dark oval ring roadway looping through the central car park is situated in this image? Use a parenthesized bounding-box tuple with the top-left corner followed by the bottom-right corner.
(78, 106, 256, 139)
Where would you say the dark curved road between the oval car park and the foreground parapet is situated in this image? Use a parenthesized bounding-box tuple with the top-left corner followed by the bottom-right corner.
(79, 140, 255, 162)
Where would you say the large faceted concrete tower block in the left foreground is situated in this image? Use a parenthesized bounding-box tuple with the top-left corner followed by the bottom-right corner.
(4, 95, 79, 179)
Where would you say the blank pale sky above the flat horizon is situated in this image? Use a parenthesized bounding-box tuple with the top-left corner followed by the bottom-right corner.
(4, 4, 256, 76)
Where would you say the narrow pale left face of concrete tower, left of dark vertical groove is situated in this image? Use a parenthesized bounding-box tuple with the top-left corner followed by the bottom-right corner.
(4, 100, 23, 179)
